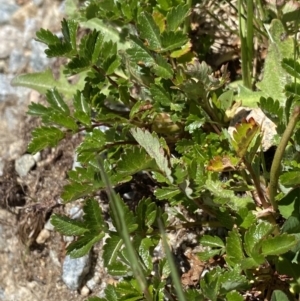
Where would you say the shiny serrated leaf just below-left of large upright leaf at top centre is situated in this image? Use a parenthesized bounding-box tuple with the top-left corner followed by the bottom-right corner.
(126, 36, 155, 66)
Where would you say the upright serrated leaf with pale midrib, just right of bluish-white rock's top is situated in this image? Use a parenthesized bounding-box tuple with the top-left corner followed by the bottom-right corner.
(102, 233, 124, 267)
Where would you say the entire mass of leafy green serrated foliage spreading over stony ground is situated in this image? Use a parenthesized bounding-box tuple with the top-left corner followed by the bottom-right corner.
(14, 0, 300, 300)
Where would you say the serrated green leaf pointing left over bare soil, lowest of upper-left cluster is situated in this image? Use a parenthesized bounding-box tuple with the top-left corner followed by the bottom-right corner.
(28, 126, 64, 153)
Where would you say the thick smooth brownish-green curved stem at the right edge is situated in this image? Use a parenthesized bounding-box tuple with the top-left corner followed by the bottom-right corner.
(268, 106, 300, 211)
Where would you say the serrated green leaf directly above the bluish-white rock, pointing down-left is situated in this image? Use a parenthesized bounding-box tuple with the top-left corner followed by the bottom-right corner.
(67, 232, 105, 258)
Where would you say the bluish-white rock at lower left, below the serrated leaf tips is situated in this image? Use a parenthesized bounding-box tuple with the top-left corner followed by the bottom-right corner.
(62, 254, 91, 290)
